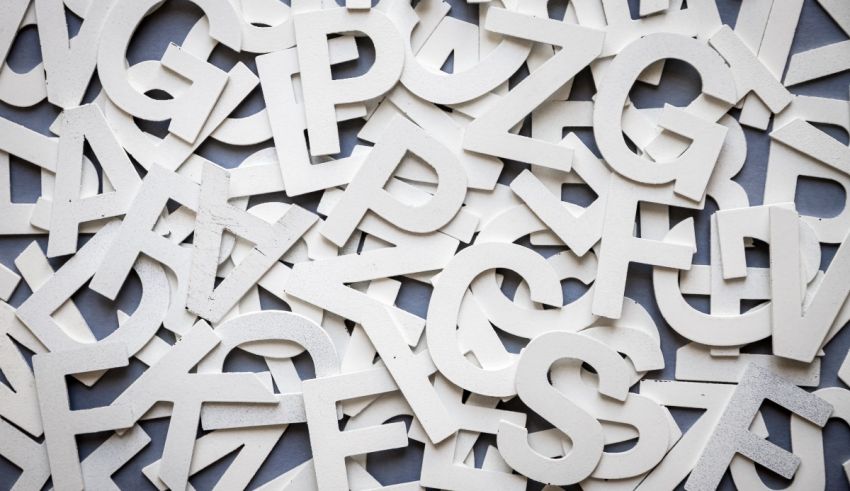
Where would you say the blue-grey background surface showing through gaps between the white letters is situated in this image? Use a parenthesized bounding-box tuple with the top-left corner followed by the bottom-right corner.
(0, 0, 850, 489)
